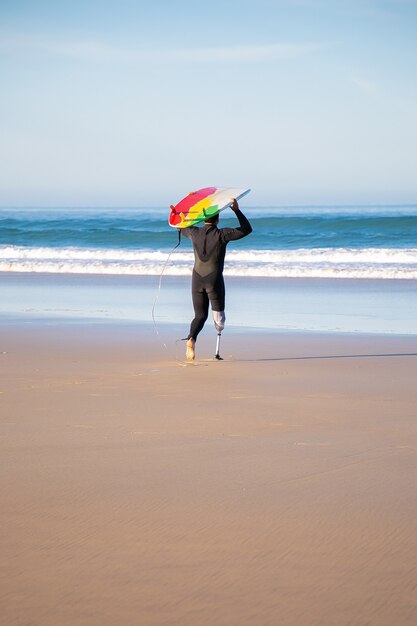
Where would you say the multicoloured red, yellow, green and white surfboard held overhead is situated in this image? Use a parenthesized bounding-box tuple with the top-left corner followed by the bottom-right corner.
(168, 187, 250, 228)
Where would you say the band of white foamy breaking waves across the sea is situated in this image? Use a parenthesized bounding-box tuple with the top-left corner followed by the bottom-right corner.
(0, 246, 417, 280)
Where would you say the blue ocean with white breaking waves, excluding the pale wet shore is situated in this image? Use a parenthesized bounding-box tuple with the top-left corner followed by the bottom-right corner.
(0, 205, 417, 280)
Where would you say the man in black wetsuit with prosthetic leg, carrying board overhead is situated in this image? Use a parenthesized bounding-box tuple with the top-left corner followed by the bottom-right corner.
(182, 200, 252, 361)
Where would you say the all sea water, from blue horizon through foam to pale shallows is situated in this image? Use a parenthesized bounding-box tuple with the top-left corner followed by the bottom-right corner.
(0, 205, 417, 334)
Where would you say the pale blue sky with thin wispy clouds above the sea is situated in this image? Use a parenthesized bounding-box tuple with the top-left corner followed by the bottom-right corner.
(0, 0, 417, 206)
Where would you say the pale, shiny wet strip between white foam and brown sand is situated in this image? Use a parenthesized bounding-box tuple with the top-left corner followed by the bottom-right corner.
(0, 273, 417, 336)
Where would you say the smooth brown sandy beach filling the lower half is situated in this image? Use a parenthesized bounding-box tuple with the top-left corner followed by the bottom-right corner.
(0, 323, 417, 626)
